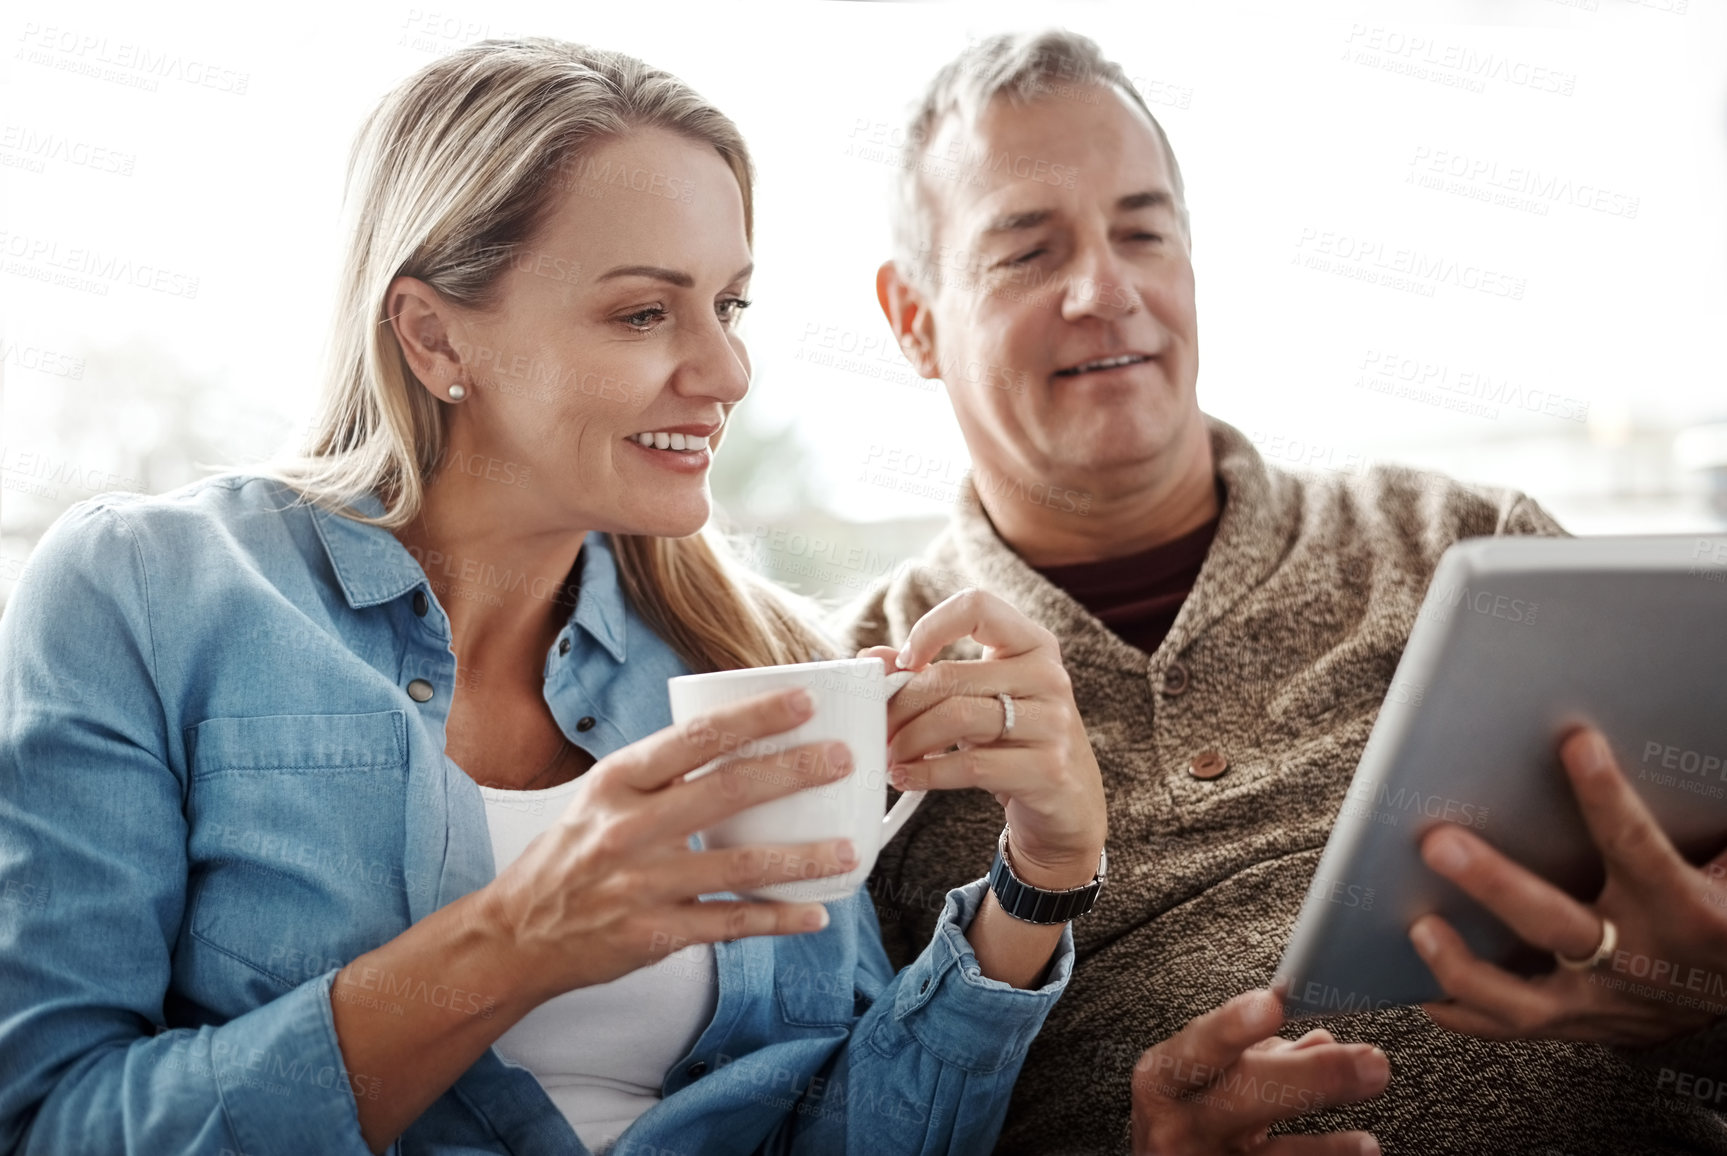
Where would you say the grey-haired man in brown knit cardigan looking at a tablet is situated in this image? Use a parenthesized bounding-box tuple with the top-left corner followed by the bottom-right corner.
(845, 33, 1727, 1156)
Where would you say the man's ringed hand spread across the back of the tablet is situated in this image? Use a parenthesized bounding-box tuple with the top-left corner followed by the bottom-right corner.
(1409, 729, 1727, 1045)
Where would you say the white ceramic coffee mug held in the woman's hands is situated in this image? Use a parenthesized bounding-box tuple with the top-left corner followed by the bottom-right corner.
(667, 658, 924, 904)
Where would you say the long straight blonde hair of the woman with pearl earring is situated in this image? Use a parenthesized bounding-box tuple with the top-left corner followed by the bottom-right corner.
(247, 36, 831, 670)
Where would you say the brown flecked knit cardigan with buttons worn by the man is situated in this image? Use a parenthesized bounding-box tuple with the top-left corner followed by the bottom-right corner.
(839, 420, 1727, 1156)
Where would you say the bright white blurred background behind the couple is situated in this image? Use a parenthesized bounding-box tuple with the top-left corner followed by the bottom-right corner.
(0, 0, 1727, 601)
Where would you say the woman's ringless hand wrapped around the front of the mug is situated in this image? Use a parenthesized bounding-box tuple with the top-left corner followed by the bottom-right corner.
(482, 689, 858, 1004)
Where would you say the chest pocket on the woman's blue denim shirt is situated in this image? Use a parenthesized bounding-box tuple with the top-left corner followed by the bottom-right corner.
(181, 710, 408, 999)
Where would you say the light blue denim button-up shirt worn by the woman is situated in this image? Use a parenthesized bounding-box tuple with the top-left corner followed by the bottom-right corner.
(0, 475, 1072, 1156)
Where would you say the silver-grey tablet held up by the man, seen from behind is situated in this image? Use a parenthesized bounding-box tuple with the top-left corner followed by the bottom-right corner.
(1276, 536, 1727, 1016)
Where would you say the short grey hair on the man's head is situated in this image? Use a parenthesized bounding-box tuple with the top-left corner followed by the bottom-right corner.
(889, 28, 1188, 282)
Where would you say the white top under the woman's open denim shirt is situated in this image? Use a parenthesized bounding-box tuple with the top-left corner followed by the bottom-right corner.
(480, 779, 718, 1156)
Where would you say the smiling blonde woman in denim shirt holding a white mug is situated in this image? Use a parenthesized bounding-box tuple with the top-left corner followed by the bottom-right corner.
(0, 40, 1104, 1156)
